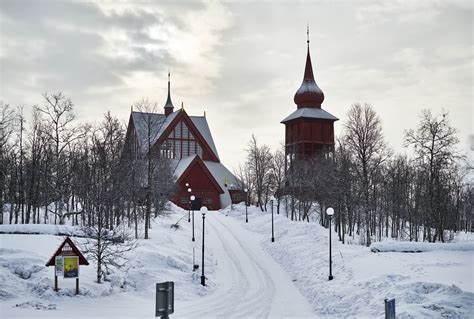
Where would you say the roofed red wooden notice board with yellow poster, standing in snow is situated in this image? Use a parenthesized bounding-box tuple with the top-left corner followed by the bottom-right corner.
(46, 237, 89, 295)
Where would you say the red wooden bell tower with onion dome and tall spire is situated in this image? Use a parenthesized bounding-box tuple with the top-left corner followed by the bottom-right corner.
(281, 28, 338, 169)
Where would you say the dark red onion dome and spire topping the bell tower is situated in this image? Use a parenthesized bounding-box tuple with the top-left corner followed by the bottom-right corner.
(294, 26, 324, 108)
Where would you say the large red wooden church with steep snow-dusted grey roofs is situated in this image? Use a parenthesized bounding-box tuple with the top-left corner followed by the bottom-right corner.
(126, 73, 238, 210)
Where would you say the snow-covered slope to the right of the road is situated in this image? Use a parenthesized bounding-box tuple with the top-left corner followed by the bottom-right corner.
(223, 205, 474, 318)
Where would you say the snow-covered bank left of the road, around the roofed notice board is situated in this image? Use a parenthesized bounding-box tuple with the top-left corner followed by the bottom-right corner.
(0, 206, 215, 318)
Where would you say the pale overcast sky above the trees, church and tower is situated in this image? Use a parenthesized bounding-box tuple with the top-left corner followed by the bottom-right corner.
(0, 0, 474, 169)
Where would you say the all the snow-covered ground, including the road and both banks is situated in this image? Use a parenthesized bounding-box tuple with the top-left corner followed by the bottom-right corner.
(0, 205, 474, 318)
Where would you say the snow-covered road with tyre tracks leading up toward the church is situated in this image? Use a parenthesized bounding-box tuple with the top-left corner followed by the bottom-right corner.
(175, 212, 315, 318)
